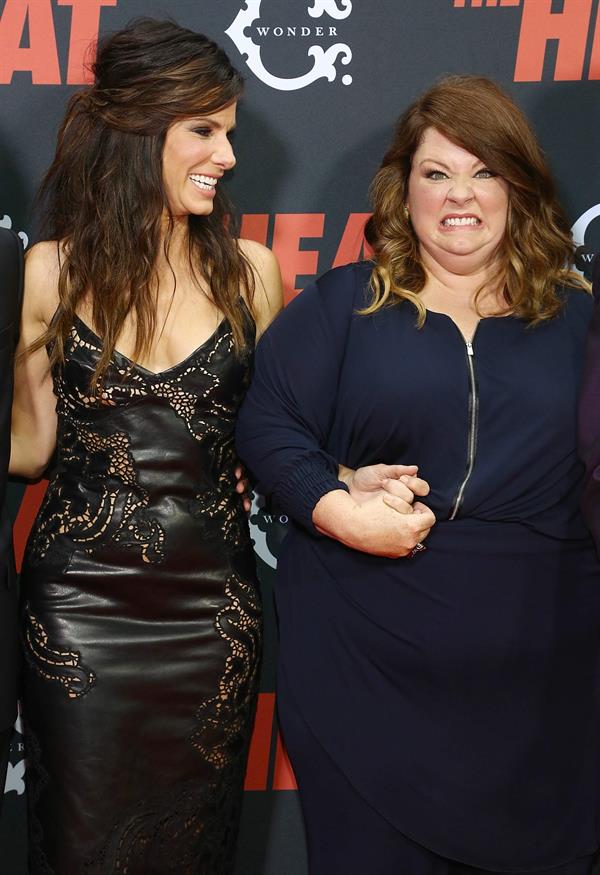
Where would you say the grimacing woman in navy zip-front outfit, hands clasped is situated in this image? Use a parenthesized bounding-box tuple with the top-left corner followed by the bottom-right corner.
(238, 76, 600, 875)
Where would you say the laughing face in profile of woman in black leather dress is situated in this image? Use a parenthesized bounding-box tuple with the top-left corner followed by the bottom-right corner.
(162, 103, 236, 218)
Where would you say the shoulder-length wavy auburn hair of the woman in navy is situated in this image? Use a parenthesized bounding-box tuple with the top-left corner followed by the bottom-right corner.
(361, 76, 589, 326)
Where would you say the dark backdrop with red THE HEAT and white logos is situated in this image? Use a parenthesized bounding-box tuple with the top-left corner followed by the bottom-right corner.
(0, 0, 600, 875)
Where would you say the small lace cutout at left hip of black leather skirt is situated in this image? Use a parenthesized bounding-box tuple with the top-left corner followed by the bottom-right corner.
(25, 608, 96, 699)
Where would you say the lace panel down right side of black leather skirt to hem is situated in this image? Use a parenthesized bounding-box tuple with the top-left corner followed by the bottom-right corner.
(85, 574, 262, 875)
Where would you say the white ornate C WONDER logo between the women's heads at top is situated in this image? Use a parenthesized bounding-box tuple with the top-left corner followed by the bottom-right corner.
(225, 0, 352, 91)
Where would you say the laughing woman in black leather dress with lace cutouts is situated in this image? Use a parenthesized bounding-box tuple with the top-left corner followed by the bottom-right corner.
(11, 20, 281, 875)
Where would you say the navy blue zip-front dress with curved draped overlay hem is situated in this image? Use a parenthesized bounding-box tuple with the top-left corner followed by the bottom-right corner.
(238, 263, 600, 872)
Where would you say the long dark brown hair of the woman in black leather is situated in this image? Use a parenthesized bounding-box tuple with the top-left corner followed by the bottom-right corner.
(32, 18, 254, 386)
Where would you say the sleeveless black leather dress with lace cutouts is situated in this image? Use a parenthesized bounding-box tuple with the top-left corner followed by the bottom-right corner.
(22, 317, 261, 875)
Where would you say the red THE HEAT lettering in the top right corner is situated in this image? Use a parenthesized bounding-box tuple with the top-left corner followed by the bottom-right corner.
(453, 0, 600, 82)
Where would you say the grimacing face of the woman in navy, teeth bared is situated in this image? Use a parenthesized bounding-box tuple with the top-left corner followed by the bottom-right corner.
(407, 128, 509, 273)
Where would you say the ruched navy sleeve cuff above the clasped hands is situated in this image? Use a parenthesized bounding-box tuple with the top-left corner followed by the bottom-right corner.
(273, 452, 349, 537)
